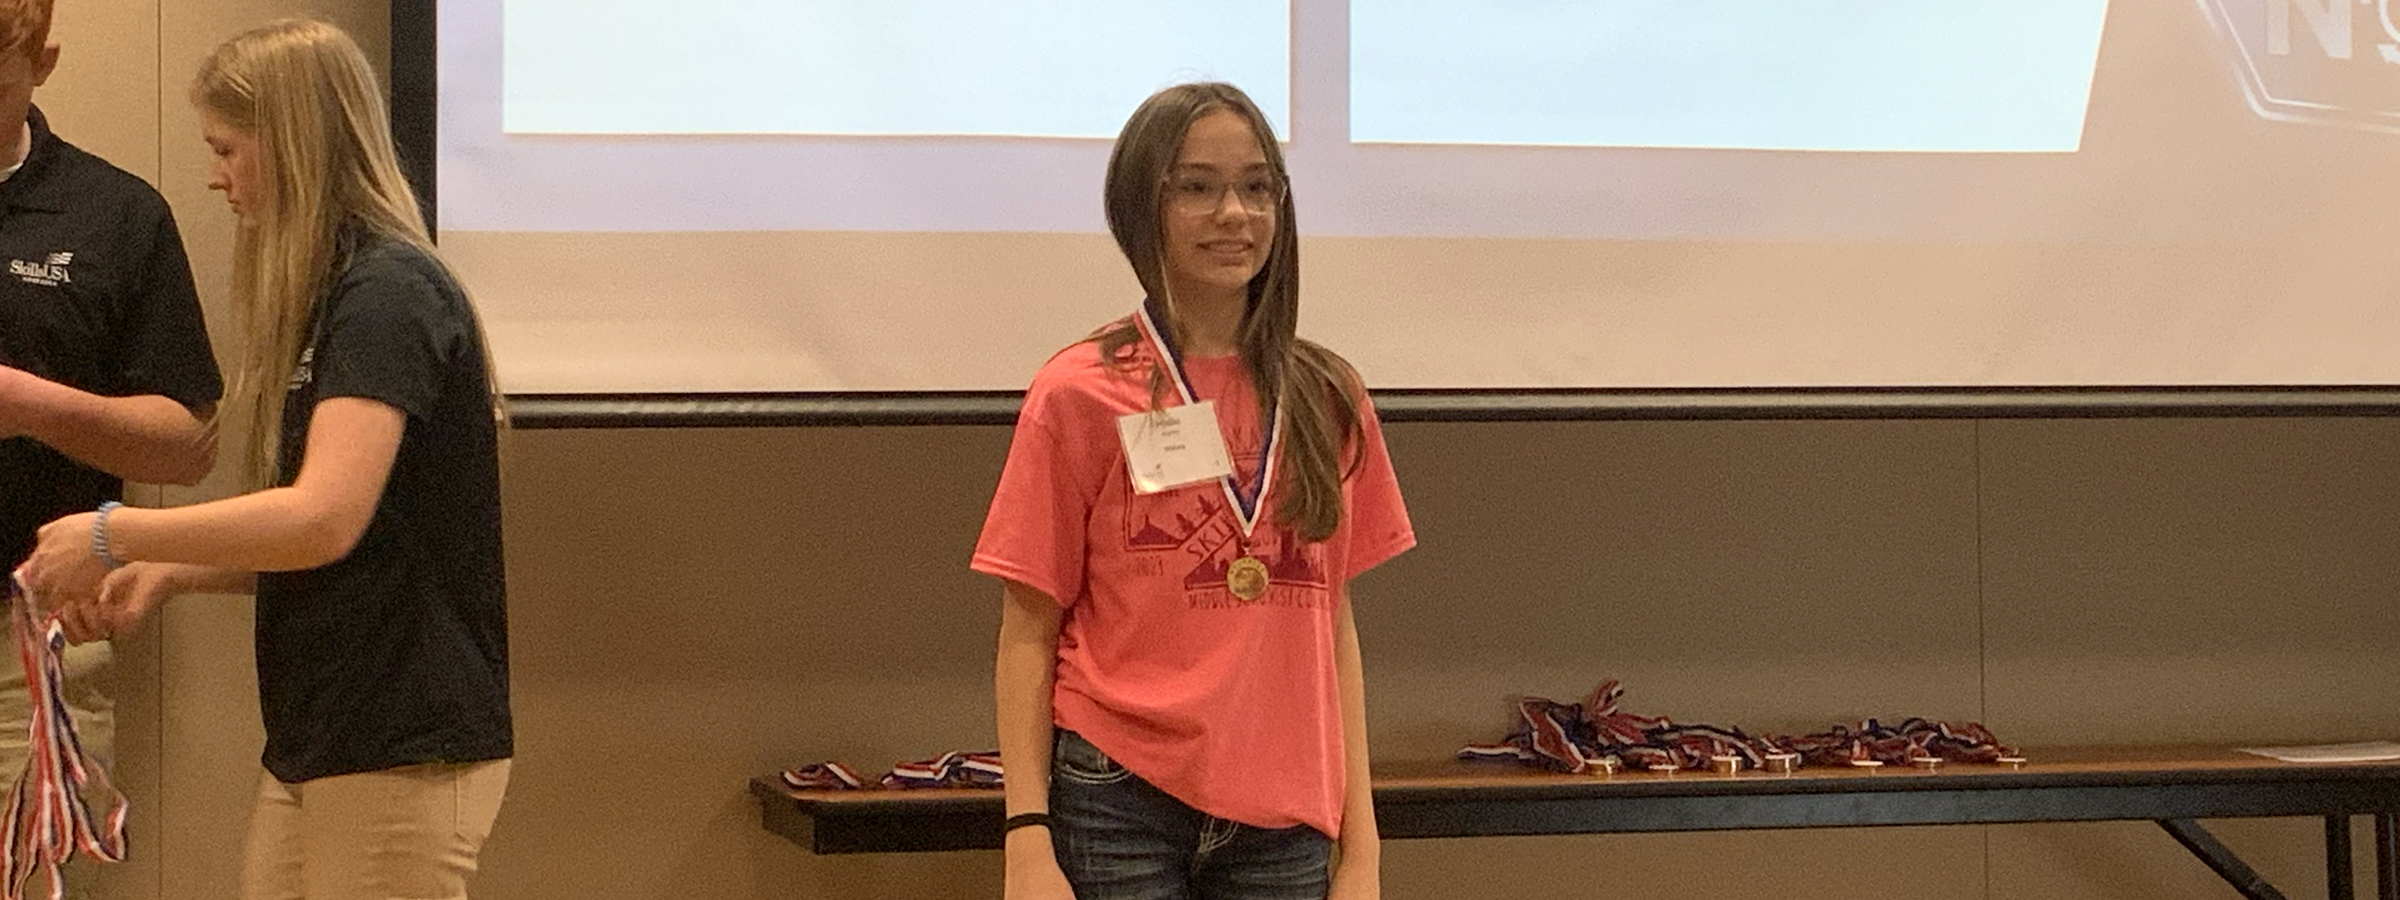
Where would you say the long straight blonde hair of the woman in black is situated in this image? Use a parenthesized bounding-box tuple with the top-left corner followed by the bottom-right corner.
(192, 19, 499, 487)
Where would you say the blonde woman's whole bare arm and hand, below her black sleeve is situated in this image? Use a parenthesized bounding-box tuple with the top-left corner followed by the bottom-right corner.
(19, 396, 408, 595)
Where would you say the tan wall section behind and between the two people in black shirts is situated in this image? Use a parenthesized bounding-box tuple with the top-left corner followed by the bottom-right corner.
(36, 0, 386, 898)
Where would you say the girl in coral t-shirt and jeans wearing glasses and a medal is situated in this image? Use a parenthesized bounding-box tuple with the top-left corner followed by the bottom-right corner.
(974, 84, 1416, 900)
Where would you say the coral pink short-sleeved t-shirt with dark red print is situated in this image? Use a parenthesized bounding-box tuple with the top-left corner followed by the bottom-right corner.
(972, 331, 1416, 838)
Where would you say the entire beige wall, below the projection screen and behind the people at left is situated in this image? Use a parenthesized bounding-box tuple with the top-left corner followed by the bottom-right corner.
(43, 0, 2400, 900)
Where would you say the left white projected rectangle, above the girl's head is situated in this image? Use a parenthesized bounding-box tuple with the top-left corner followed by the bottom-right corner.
(502, 0, 1291, 137)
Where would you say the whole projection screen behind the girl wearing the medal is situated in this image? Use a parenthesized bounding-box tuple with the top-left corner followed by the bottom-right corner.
(396, 0, 2400, 417)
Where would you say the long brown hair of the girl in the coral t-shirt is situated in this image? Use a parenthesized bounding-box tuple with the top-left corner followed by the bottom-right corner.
(1097, 82, 1363, 540)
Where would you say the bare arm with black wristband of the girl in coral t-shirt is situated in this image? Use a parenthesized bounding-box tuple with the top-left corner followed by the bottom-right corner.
(991, 581, 1073, 900)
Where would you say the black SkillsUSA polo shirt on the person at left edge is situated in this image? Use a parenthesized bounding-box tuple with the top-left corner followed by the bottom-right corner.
(0, 110, 223, 569)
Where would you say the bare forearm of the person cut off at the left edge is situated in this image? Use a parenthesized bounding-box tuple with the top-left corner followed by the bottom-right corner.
(0, 367, 216, 485)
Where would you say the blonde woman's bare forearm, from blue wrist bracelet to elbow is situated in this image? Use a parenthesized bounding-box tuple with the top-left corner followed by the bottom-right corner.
(108, 487, 358, 571)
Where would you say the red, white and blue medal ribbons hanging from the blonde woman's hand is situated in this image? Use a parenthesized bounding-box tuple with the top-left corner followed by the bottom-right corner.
(0, 576, 127, 900)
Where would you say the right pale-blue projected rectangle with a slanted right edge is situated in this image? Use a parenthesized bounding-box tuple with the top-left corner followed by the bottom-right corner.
(1349, 0, 2107, 154)
